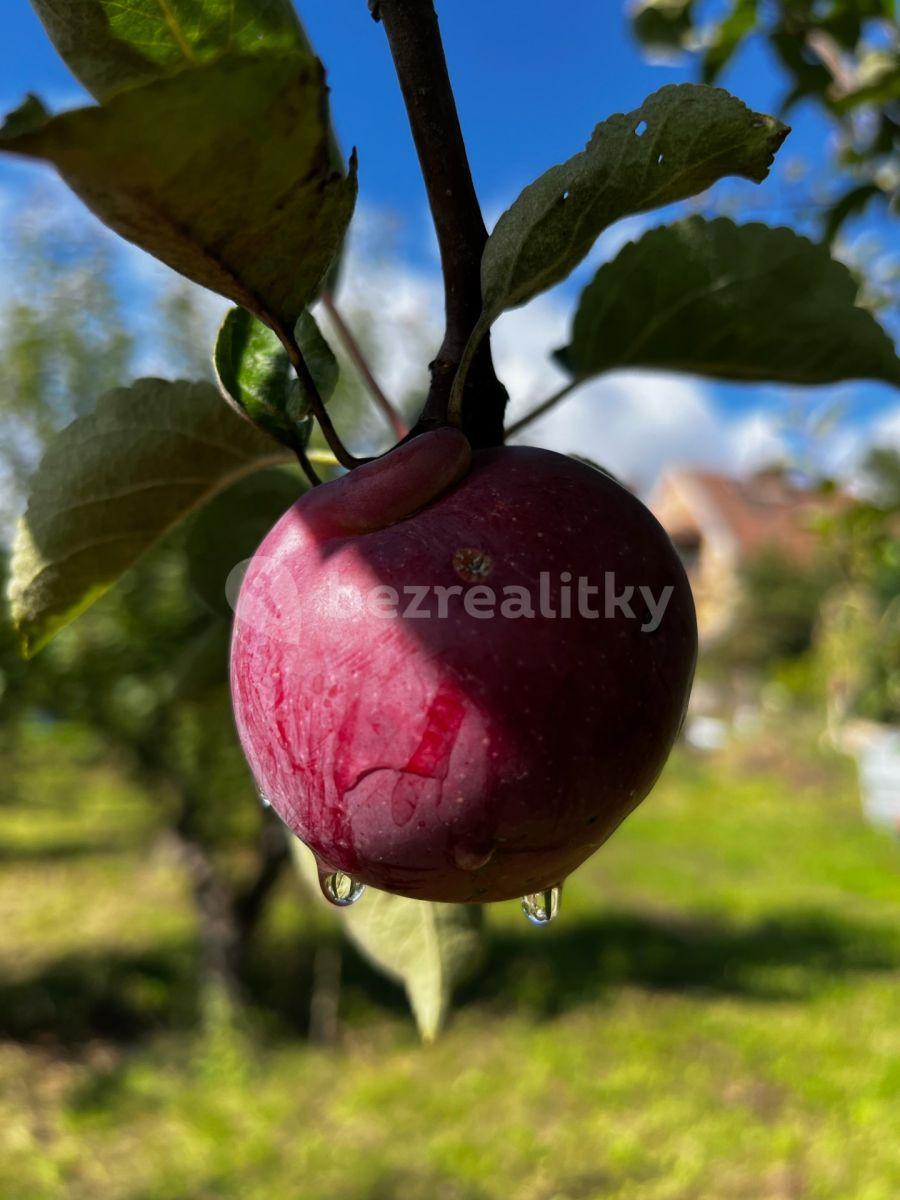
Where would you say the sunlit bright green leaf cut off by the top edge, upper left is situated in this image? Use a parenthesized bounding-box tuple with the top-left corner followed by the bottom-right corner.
(31, 0, 311, 100)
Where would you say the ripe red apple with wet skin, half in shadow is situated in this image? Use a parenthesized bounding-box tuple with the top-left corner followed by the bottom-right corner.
(232, 430, 697, 901)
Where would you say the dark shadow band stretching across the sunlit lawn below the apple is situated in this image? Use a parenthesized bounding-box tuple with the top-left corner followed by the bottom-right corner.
(0, 912, 900, 1045)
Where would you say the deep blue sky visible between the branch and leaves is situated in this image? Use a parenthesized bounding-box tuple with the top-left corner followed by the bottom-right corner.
(0, 0, 900, 482)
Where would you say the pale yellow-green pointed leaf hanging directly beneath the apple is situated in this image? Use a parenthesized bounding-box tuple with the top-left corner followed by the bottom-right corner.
(290, 836, 485, 1042)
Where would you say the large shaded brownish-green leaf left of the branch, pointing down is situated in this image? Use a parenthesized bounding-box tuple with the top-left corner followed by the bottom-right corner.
(0, 54, 356, 329)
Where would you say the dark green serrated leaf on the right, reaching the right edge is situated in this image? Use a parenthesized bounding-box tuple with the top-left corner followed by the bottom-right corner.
(558, 217, 900, 384)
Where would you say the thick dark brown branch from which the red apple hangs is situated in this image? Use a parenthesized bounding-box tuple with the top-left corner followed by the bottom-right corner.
(370, 0, 508, 449)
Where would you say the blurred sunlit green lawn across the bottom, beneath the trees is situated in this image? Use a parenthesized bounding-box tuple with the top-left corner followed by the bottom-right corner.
(0, 731, 900, 1200)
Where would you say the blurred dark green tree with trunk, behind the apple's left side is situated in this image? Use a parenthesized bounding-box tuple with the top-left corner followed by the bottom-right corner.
(2, 518, 300, 995)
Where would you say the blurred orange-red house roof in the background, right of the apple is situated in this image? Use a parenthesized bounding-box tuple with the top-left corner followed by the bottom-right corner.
(652, 469, 842, 558)
